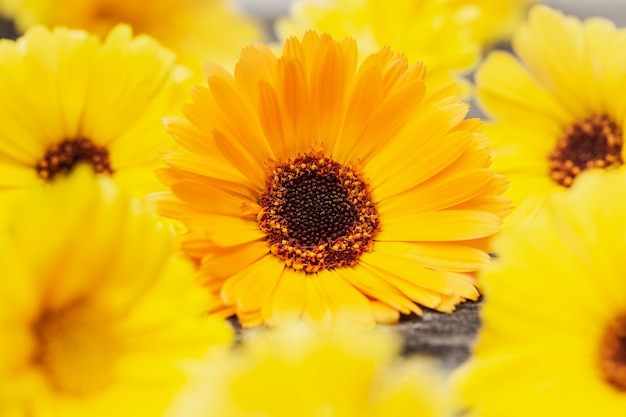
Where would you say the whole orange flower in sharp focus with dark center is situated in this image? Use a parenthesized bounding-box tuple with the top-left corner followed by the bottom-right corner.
(155, 32, 509, 327)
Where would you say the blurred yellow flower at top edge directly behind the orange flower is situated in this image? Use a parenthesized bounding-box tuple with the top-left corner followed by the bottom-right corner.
(276, 0, 481, 91)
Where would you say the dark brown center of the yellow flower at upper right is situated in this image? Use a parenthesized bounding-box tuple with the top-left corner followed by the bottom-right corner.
(549, 115, 623, 187)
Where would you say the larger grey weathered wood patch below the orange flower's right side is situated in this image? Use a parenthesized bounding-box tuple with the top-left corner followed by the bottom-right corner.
(394, 302, 481, 370)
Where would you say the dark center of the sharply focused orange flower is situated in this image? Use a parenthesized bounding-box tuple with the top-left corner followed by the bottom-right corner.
(258, 154, 380, 273)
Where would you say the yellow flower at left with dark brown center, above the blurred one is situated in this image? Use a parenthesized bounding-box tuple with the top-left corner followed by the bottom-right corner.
(0, 26, 189, 221)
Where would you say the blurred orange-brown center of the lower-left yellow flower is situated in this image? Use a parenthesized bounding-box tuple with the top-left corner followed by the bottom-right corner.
(33, 303, 116, 396)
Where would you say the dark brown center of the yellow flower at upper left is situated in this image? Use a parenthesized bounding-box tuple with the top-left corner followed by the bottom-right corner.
(36, 138, 113, 181)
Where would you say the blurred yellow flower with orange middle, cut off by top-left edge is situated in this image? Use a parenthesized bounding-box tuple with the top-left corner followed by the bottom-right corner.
(0, 0, 262, 69)
